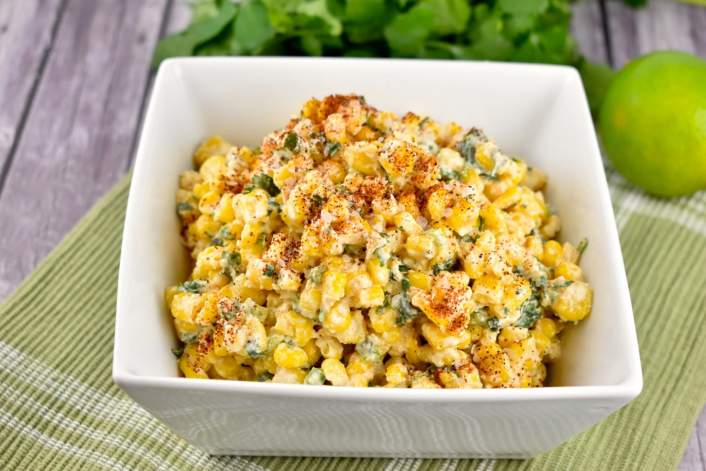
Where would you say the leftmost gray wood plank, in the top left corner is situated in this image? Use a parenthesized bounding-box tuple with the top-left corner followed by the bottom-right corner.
(0, 0, 63, 189)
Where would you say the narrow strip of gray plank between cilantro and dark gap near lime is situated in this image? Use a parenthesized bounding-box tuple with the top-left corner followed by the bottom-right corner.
(571, 0, 609, 64)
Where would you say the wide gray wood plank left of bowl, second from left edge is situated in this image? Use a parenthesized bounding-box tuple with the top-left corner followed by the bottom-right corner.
(0, 0, 167, 298)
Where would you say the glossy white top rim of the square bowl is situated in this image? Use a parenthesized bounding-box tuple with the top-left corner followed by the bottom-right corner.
(112, 56, 643, 402)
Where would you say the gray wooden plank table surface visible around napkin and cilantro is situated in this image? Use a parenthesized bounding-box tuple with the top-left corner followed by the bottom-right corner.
(0, 0, 706, 471)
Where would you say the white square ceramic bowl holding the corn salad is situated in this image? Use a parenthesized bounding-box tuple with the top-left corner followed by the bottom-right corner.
(113, 58, 642, 458)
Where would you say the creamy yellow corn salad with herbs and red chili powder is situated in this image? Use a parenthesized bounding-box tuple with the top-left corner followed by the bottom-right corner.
(166, 95, 592, 388)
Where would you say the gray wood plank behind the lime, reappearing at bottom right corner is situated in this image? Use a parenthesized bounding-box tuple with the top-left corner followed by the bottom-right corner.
(606, 0, 706, 471)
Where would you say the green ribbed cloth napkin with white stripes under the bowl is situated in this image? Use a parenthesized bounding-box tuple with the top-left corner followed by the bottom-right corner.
(0, 169, 706, 471)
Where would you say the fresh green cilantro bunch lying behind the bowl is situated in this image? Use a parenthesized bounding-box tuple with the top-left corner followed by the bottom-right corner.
(153, 0, 612, 115)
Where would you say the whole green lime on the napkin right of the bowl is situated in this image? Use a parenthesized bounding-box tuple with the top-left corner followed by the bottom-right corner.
(598, 51, 706, 196)
